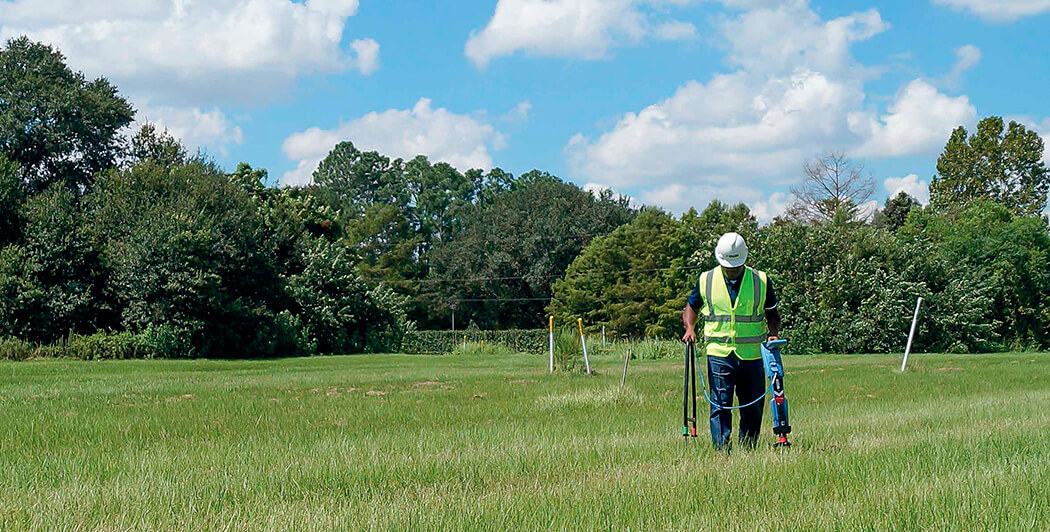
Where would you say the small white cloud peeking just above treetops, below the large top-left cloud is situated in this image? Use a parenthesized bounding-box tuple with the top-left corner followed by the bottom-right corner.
(135, 102, 244, 155)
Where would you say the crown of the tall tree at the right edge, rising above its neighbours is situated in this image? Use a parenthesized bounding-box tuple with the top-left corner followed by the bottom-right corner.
(929, 116, 1050, 216)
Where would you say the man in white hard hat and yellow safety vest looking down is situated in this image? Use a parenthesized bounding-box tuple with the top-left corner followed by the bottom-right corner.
(681, 233, 780, 450)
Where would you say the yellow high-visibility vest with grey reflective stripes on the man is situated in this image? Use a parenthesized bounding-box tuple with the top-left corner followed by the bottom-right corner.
(699, 267, 769, 360)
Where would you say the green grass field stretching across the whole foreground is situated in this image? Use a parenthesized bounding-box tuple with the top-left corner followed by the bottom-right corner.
(0, 354, 1050, 531)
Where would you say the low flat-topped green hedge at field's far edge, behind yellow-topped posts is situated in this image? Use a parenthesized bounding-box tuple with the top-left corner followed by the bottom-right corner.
(401, 328, 547, 355)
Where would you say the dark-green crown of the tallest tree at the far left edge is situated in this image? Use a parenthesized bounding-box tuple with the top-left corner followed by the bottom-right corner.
(0, 37, 134, 194)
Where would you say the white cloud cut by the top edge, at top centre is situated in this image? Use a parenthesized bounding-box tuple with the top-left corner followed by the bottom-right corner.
(465, 0, 696, 67)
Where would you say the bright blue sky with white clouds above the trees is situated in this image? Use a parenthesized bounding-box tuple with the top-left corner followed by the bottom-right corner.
(0, 0, 1050, 219)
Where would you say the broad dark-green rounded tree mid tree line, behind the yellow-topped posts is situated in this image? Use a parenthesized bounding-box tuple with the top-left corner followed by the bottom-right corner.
(424, 171, 635, 327)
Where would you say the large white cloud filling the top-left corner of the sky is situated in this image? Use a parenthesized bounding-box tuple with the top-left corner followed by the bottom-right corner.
(0, 0, 378, 105)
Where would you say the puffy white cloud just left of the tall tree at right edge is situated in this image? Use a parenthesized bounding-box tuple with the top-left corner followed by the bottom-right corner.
(849, 80, 977, 157)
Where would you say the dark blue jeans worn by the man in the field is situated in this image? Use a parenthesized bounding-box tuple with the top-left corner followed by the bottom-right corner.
(708, 353, 765, 449)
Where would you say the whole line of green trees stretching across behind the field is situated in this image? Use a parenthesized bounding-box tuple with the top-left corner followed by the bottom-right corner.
(0, 38, 1050, 357)
